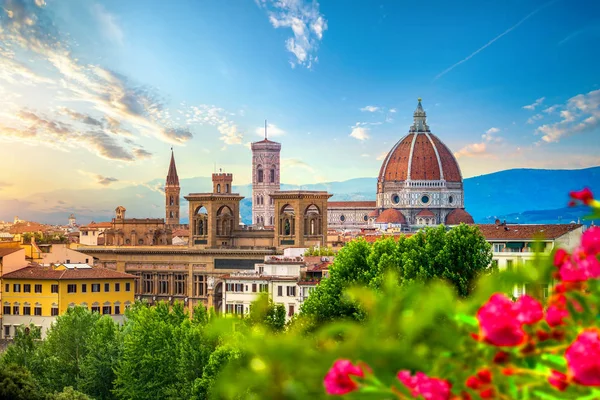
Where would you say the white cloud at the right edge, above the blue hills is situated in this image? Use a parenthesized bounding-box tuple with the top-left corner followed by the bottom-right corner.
(536, 90, 600, 143)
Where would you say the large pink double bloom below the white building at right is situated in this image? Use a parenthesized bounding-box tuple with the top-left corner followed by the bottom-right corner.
(477, 293, 543, 346)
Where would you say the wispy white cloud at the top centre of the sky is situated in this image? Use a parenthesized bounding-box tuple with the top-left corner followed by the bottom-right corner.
(256, 0, 327, 69)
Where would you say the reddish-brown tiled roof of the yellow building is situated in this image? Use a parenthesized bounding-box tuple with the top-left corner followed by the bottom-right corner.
(2, 265, 135, 280)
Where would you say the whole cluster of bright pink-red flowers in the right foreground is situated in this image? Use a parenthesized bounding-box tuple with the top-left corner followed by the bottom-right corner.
(324, 188, 600, 400)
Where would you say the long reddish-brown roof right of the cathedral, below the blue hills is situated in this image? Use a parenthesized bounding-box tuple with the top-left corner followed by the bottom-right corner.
(477, 224, 582, 240)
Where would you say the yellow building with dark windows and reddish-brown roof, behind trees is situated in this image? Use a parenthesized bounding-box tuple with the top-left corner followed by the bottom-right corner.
(2, 265, 135, 338)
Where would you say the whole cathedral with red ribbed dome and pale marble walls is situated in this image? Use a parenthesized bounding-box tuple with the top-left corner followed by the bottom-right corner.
(327, 99, 473, 231)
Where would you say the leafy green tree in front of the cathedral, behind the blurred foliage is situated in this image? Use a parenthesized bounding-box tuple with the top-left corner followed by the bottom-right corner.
(301, 224, 492, 325)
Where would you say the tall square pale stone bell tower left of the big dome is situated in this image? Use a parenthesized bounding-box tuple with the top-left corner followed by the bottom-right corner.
(251, 121, 281, 226)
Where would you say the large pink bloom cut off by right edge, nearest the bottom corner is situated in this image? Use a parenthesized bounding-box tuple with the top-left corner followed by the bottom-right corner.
(565, 329, 600, 386)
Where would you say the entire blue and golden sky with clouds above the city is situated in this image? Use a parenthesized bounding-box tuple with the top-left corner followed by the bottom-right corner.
(0, 0, 600, 219)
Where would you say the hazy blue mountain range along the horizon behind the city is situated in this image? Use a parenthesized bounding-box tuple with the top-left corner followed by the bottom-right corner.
(0, 166, 600, 224)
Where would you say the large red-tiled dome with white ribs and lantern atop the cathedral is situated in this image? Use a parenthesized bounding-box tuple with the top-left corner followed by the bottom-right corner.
(378, 99, 462, 183)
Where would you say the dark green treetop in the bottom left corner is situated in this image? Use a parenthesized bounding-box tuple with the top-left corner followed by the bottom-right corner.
(0, 363, 45, 400)
